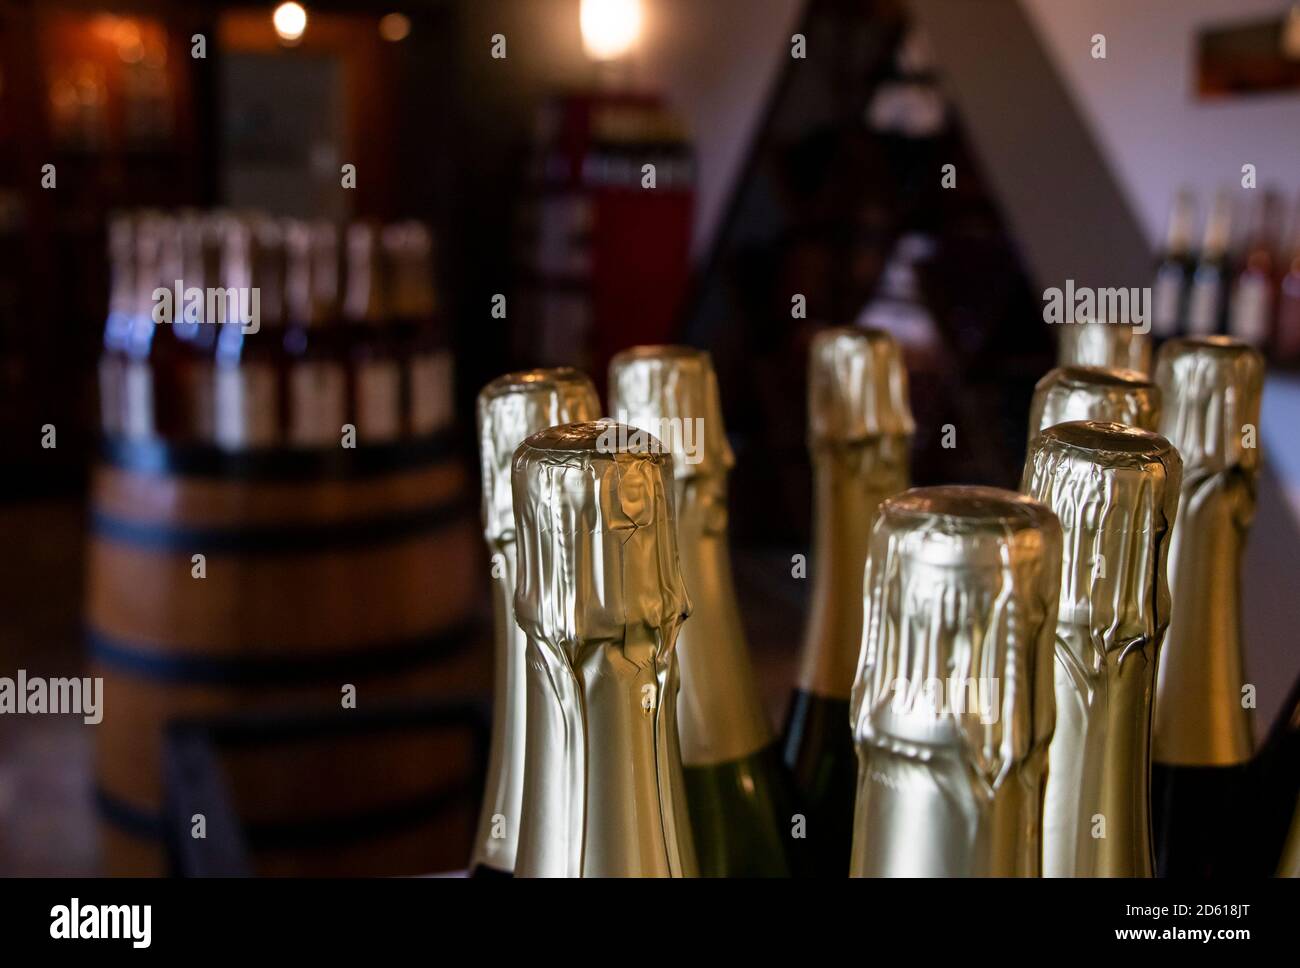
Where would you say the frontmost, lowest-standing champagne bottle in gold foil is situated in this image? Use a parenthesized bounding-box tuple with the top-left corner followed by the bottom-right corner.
(852, 487, 1061, 877)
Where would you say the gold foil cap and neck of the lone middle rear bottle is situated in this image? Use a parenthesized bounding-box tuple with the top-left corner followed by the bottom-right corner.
(798, 326, 915, 699)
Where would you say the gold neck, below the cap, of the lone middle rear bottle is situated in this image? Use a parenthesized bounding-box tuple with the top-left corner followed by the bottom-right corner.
(798, 435, 910, 699)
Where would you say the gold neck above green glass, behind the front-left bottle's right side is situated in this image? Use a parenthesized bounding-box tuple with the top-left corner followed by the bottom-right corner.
(675, 473, 771, 767)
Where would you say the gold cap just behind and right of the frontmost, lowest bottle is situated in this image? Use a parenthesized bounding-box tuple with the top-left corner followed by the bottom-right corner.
(1024, 421, 1183, 644)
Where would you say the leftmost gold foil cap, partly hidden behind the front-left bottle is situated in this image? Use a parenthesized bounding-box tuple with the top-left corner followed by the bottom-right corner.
(478, 366, 601, 543)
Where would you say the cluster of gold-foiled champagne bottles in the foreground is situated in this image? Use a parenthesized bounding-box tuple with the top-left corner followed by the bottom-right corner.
(475, 327, 1300, 877)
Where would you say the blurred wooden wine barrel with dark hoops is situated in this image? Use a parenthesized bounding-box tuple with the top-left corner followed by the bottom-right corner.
(87, 439, 482, 874)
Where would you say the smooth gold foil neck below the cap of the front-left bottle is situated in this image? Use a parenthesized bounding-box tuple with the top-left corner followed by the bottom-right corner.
(516, 628, 696, 877)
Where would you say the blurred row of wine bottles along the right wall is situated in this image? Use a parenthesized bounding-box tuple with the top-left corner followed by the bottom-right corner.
(1151, 187, 1300, 366)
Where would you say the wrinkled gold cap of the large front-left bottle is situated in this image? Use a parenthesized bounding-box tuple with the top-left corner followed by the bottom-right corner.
(512, 420, 690, 652)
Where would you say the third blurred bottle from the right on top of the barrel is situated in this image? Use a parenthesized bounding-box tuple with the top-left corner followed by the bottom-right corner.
(285, 220, 350, 447)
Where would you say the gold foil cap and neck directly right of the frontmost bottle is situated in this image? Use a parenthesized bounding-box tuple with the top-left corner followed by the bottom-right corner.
(1022, 421, 1183, 877)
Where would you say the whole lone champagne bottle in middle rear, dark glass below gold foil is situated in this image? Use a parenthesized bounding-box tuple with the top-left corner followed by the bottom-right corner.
(784, 327, 914, 877)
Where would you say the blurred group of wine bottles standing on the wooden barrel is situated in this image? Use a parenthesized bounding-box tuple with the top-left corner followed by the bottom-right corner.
(99, 210, 452, 451)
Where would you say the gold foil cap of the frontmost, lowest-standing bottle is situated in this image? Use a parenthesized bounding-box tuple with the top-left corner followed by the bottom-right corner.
(852, 486, 1061, 793)
